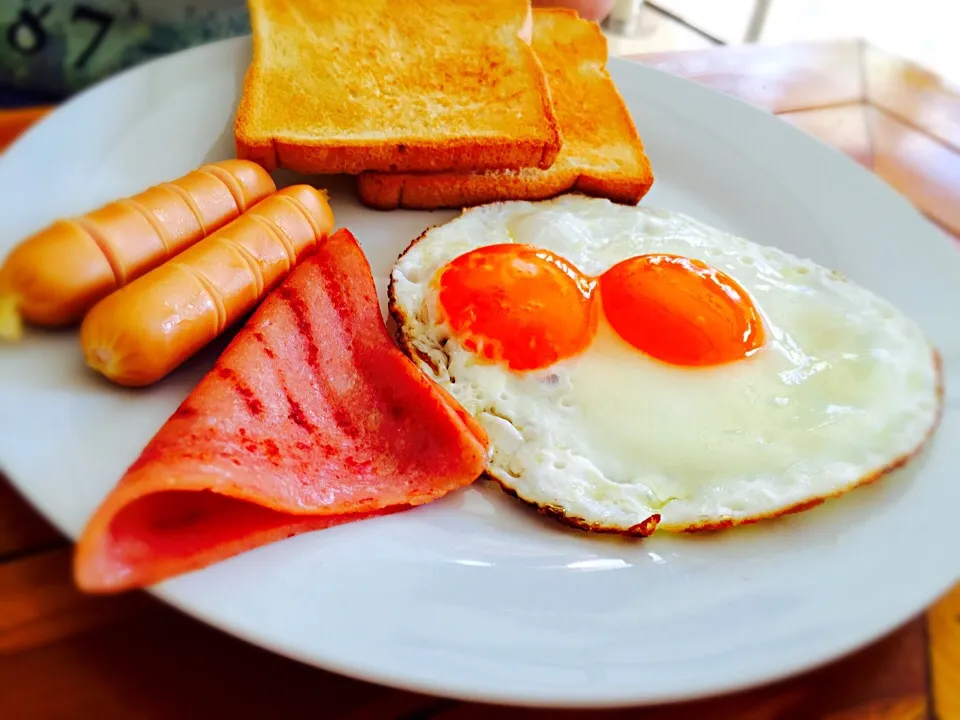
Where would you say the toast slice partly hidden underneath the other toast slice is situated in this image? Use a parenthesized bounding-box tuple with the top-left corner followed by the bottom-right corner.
(358, 10, 653, 210)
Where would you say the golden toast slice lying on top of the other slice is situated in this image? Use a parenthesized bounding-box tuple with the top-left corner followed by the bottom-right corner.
(235, 0, 561, 173)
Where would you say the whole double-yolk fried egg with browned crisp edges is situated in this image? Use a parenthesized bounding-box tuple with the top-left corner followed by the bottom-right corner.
(390, 195, 940, 536)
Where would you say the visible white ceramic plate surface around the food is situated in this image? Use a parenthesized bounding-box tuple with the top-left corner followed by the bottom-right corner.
(0, 40, 960, 705)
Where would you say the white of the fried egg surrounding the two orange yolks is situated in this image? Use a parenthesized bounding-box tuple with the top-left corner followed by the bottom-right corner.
(391, 195, 940, 534)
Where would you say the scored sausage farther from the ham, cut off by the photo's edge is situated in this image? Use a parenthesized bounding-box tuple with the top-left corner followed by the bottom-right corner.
(0, 160, 276, 340)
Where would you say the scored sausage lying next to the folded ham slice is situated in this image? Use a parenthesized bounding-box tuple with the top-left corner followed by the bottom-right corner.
(80, 185, 333, 386)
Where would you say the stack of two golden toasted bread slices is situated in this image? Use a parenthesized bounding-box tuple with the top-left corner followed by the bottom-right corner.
(235, 0, 653, 209)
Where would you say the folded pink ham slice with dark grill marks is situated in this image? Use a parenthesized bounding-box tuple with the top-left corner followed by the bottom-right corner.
(74, 230, 486, 592)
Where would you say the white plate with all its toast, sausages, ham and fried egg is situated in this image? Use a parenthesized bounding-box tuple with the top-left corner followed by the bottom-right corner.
(0, 0, 960, 706)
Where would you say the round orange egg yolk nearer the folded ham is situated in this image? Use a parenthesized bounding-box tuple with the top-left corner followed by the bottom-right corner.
(438, 244, 597, 370)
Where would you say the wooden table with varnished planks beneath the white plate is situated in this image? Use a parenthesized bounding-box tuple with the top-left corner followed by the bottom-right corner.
(0, 42, 960, 720)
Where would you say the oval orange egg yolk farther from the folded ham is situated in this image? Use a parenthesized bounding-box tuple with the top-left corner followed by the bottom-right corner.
(599, 255, 764, 365)
